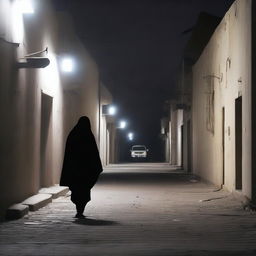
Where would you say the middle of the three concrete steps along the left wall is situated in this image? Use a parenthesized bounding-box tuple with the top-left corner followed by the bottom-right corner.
(22, 194, 52, 211)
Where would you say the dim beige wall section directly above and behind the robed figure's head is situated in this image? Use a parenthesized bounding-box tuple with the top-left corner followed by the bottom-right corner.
(56, 13, 100, 142)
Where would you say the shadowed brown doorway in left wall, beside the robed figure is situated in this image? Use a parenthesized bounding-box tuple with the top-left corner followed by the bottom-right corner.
(39, 92, 53, 187)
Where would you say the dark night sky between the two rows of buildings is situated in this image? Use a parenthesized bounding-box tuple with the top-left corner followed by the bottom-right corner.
(53, 0, 233, 161)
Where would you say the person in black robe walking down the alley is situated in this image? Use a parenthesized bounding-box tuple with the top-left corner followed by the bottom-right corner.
(60, 116, 103, 218)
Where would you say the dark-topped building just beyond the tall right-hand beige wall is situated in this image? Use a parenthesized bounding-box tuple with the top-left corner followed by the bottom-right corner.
(169, 13, 221, 171)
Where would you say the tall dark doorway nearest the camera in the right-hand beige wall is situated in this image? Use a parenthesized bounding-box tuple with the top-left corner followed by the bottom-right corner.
(235, 97, 242, 190)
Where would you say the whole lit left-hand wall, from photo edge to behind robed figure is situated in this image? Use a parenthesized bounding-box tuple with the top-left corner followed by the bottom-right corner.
(0, 0, 102, 216)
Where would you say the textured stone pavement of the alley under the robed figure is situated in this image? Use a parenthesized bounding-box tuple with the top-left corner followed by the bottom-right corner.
(0, 165, 256, 256)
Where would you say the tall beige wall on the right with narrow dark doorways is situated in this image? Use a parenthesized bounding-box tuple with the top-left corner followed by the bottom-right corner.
(192, 0, 252, 198)
